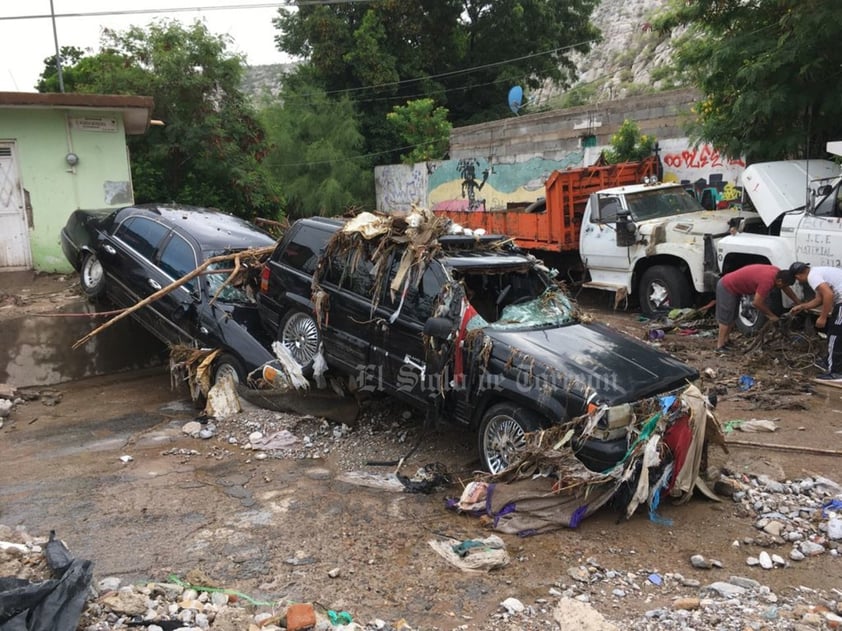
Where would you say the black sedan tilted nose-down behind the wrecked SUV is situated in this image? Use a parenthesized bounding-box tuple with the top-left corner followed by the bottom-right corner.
(61, 204, 275, 383)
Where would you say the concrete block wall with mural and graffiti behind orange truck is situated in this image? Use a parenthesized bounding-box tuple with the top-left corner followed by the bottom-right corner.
(375, 90, 745, 212)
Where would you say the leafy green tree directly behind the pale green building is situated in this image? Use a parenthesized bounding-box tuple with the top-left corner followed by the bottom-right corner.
(39, 21, 282, 218)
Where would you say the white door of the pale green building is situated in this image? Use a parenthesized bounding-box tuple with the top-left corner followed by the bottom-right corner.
(0, 142, 32, 269)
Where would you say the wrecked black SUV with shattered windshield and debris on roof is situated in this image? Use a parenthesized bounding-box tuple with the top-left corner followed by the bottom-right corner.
(258, 211, 698, 473)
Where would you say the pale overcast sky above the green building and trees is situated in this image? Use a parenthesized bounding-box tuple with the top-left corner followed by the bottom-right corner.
(0, 0, 287, 92)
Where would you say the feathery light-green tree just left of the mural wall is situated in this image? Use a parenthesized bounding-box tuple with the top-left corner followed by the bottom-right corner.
(261, 78, 374, 219)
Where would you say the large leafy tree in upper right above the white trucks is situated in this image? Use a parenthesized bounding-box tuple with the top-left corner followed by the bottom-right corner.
(653, 0, 842, 161)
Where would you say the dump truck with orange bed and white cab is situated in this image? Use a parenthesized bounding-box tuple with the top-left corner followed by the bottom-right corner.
(436, 156, 746, 314)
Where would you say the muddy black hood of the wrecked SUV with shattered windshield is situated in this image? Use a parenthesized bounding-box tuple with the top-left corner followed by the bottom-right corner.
(485, 324, 698, 405)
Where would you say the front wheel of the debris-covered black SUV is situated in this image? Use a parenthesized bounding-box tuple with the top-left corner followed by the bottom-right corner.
(479, 403, 543, 473)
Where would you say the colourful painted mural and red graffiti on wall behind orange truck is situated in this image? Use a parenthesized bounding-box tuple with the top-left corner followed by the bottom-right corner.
(375, 138, 745, 212)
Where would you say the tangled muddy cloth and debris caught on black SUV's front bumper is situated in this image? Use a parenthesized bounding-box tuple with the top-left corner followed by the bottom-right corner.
(447, 386, 727, 536)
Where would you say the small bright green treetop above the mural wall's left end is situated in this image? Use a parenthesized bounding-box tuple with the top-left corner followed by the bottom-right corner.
(386, 99, 452, 164)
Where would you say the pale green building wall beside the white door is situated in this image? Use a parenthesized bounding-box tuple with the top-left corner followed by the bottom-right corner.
(0, 108, 133, 272)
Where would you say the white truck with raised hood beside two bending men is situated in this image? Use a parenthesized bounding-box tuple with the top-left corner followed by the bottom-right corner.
(716, 149, 842, 333)
